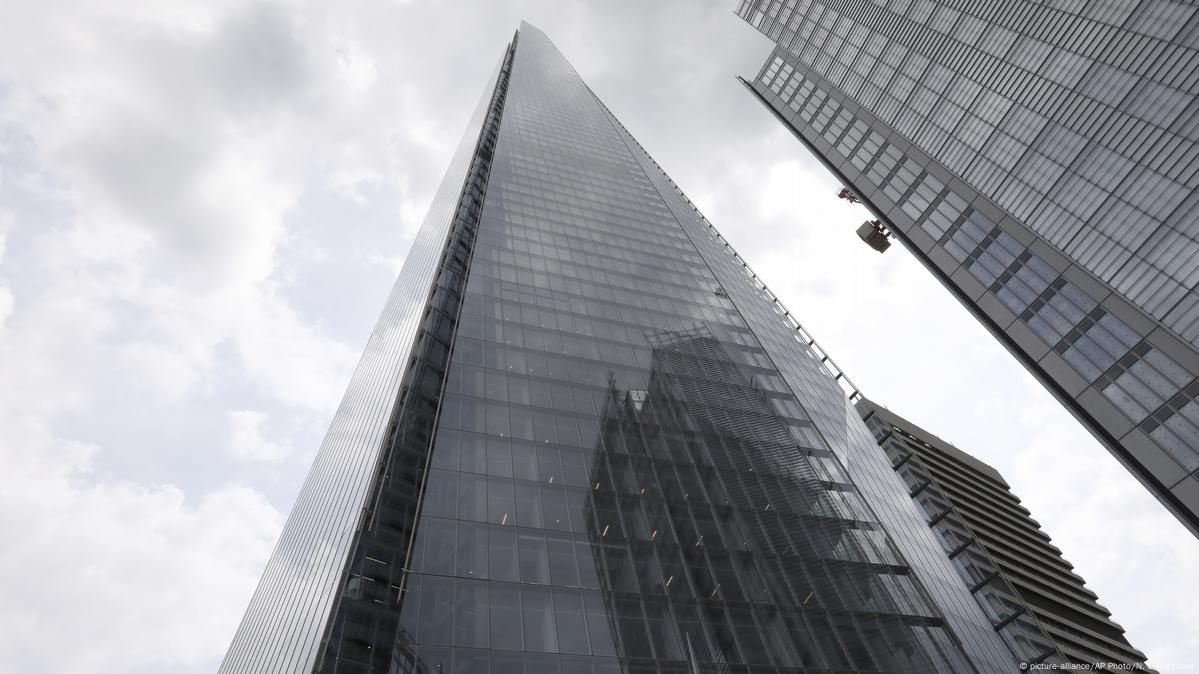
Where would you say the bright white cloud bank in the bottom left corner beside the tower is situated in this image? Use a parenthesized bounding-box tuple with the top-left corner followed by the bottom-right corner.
(0, 419, 281, 674)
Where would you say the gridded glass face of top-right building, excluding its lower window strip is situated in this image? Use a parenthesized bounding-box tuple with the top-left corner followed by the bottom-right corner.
(741, 0, 1199, 342)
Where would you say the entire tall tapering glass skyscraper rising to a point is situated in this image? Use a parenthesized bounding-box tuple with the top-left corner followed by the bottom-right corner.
(221, 24, 1014, 674)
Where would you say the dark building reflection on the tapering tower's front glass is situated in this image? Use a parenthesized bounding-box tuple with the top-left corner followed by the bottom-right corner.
(586, 325, 969, 672)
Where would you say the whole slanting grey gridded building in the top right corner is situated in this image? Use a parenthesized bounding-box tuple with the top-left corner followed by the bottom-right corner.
(737, 0, 1199, 535)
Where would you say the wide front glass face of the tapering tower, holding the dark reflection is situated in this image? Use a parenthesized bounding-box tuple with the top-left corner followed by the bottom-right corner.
(318, 25, 974, 673)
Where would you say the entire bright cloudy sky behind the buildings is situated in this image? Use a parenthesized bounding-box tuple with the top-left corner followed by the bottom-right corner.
(0, 0, 1199, 674)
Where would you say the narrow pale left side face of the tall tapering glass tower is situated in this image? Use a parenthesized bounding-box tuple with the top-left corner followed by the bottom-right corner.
(219, 56, 500, 674)
